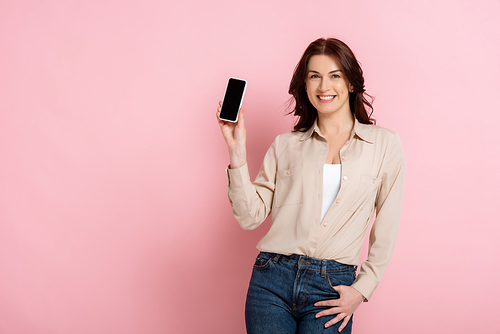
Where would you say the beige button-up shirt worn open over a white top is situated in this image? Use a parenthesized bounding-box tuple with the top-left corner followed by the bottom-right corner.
(227, 120, 405, 300)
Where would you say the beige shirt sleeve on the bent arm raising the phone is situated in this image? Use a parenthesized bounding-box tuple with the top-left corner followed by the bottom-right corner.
(226, 136, 279, 230)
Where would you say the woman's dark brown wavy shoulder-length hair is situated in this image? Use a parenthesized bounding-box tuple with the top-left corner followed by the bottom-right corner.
(288, 38, 375, 132)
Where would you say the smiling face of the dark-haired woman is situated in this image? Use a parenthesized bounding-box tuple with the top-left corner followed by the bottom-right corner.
(306, 55, 352, 115)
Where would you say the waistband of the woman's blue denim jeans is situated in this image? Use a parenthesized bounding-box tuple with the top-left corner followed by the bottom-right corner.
(259, 252, 357, 273)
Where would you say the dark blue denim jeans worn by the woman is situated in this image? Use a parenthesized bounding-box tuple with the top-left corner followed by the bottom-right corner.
(245, 252, 356, 334)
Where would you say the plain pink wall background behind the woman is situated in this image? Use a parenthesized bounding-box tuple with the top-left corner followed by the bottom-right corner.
(0, 0, 500, 334)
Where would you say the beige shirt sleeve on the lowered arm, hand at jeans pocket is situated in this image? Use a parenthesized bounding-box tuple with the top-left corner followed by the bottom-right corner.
(352, 135, 405, 301)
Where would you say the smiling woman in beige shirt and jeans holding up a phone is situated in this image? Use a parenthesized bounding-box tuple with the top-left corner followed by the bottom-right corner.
(217, 38, 405, 334)
